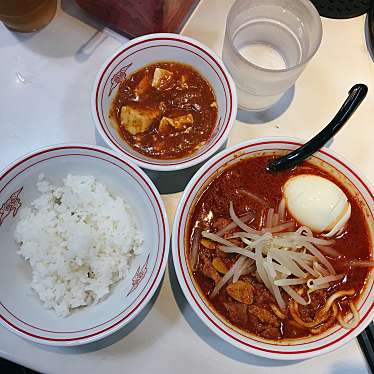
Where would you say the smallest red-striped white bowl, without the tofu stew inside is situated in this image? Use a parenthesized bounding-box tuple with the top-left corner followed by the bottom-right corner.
(91, 33, 237, 172)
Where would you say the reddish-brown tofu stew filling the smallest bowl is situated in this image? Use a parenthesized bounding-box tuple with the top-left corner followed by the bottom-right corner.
(110, 62, 217, 159)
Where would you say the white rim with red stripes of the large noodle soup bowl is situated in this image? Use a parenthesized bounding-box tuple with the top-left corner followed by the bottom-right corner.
(172, 137, 374, 360)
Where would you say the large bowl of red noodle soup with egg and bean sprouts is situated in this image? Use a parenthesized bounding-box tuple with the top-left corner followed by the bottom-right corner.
(172, 138, 374, 360)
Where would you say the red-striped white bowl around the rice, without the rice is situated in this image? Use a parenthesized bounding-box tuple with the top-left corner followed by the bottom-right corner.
(0, 144, 169, 346)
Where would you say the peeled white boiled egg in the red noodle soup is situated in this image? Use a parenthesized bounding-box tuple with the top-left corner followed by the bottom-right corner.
(283, 174, 351, 237)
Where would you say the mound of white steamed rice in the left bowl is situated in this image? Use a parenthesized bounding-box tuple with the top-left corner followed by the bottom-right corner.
(15, 175, 143, 316)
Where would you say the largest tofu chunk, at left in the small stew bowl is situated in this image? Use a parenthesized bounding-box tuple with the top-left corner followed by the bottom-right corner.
(121, 106, 160, 135)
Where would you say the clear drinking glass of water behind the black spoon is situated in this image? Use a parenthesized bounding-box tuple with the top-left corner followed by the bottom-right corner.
(222, 0, 322, 110)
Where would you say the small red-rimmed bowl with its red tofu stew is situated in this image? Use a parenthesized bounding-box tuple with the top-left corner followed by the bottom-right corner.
(91, 34, 237, 171)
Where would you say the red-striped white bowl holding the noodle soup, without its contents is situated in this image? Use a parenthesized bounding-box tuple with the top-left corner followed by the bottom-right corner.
(172, 138, 374, 360)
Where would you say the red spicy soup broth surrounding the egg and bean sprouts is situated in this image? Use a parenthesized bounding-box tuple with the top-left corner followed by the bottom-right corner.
(186, 156, 371, 340)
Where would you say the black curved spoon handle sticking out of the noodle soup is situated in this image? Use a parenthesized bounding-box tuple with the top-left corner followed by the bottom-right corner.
(266, 84, 368, 172)
